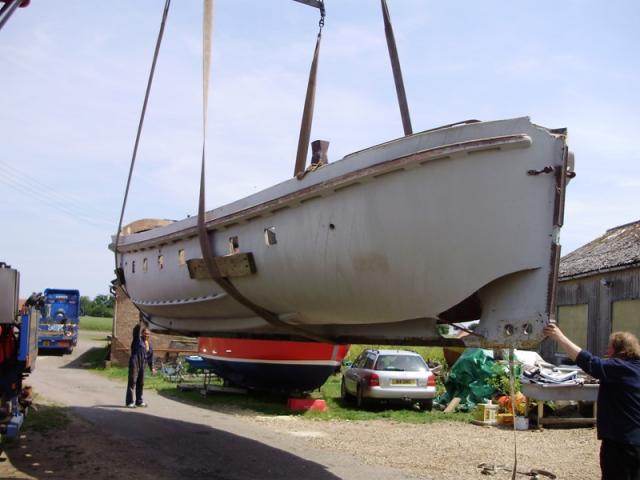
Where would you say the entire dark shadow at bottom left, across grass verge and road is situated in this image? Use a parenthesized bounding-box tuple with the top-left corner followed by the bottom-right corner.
(0, 406, 339, 480)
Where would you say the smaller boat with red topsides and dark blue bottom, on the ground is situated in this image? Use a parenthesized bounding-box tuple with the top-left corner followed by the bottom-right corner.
(189, 337, 350, 392)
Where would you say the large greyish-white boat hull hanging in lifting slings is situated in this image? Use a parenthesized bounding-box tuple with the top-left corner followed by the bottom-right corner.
(112, 118, 573, 348)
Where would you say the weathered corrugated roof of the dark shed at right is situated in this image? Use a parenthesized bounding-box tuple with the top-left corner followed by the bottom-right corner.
(559, 220, 640, 280)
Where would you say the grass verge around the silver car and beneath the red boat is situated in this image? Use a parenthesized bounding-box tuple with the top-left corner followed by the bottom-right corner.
(81, 345, 471, 423)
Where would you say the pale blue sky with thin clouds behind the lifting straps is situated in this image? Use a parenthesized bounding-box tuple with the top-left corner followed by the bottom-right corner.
(0, 0, 640, 297)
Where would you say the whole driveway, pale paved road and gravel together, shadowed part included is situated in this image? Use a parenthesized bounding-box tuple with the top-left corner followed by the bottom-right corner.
(0, 338, 600, 480)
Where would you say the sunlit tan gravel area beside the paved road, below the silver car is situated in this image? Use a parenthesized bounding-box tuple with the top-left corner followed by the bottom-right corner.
(255, 416, 600, 480)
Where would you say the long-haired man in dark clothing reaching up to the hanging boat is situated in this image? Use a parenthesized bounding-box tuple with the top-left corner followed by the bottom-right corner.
(544, 324, 640, 480)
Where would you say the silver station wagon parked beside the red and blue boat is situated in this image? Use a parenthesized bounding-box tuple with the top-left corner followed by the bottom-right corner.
(340, 350, 436, 410)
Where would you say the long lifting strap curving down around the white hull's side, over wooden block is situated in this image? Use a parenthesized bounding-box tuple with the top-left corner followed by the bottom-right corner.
(198, 0, 330, 343)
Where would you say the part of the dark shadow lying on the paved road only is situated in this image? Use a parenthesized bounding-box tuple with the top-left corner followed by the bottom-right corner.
(75, 405, 338, 480)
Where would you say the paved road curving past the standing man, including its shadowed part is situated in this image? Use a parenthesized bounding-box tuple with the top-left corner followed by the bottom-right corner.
(30, 334, 418, 480)
